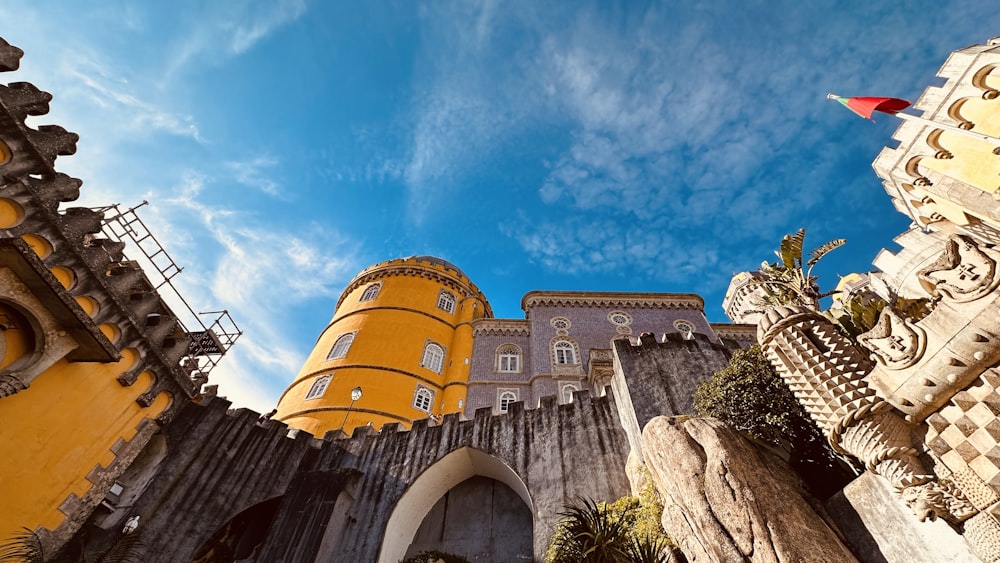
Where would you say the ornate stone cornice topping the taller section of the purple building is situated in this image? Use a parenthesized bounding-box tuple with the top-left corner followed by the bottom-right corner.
(521, 291, 705, 311)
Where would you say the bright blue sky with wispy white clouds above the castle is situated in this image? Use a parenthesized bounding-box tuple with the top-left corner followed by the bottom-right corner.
(0, 0, 1000, 411)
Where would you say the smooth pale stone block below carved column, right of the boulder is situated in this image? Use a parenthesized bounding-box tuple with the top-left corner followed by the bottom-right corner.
(826, 473, 979, 563)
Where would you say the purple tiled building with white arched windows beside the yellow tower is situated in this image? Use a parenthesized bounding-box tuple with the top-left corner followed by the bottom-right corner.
(464, 291, 754, 416)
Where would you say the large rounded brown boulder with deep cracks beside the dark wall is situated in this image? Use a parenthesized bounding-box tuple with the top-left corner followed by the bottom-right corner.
(642, 417, 856, 563)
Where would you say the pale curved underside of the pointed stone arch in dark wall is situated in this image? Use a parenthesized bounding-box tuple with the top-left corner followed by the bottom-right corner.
(378, 446, 535, 563)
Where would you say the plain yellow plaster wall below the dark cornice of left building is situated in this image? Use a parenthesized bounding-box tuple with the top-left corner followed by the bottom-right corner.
(0, 350, 170, 537)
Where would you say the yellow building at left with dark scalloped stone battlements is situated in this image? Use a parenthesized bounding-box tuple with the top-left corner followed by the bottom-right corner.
(0, 39, 238, 549)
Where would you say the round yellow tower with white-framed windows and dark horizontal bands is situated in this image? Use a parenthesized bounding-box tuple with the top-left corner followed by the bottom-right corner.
(274, 256, 493, 436)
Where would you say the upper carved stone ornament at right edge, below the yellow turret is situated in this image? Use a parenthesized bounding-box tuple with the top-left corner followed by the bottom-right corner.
(917, 235, 1000, 303)
